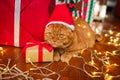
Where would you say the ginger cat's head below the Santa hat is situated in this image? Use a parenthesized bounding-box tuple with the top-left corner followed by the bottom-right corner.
(44, 24, 74, 48)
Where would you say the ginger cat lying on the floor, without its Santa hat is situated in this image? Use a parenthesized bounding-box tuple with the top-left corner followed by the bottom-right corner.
(44, 18, 96, 63)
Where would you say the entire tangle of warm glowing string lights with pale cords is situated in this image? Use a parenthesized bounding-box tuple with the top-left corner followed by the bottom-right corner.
(0, 22, 120, 80)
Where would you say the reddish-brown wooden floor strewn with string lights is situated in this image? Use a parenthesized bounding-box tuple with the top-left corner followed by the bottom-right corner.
(0, 17, 120, 80)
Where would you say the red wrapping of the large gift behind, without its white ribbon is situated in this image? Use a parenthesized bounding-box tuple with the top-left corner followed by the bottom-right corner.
(0, 0, 54, 47)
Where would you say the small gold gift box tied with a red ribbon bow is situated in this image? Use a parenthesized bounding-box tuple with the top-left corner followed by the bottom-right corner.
(22, 43, 53, 63)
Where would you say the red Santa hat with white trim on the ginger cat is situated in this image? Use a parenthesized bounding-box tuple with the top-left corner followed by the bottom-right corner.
(46, 4, 74, 30)
